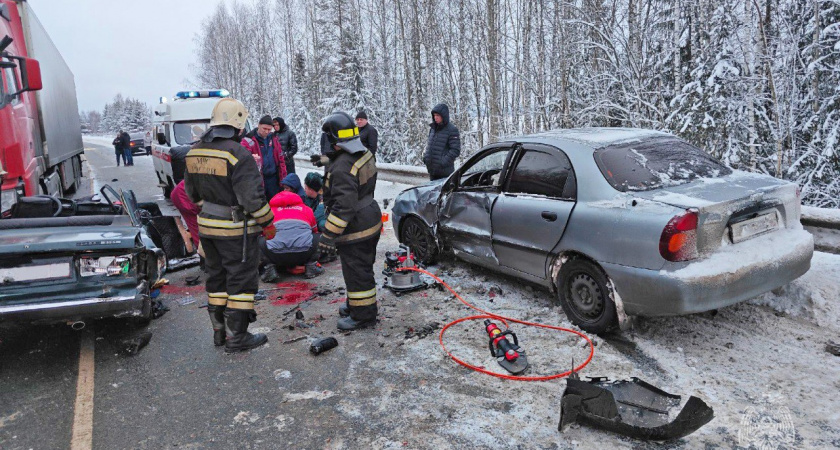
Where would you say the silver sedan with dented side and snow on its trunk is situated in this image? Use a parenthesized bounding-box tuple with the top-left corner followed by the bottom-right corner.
(392, 128, 814, 333)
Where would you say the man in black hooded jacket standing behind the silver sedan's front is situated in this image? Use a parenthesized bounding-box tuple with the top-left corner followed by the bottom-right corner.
(423, 103, 461, 180)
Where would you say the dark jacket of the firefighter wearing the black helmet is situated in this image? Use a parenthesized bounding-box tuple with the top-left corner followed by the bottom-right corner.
(324, 150, 382, 244)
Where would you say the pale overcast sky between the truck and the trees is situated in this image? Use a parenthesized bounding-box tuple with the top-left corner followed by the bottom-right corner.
(28, 0, 225, 111)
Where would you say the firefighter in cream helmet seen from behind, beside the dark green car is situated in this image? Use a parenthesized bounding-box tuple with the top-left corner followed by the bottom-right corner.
(184, 98, 276, 353)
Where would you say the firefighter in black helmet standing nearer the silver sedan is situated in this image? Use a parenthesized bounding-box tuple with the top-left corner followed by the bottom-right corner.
(312, 113, 382, 330)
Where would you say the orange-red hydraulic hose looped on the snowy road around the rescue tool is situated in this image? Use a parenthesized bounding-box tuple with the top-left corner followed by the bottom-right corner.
(397, 267, 595, 381)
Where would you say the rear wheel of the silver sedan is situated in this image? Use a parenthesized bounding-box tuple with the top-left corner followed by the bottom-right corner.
(557, 258, 618, 334)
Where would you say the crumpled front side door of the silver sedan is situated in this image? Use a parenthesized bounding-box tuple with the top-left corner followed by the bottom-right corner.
(438, 144, 511, 266)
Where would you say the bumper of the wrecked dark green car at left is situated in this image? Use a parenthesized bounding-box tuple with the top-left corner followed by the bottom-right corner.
(0, 281, 151, 323)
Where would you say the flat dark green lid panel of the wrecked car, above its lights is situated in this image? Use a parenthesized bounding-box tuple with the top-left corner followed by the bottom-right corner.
(0, 226, 140, 255)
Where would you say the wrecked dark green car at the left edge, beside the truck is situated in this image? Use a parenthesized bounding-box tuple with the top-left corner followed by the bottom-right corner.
(0, 186, 167, 329)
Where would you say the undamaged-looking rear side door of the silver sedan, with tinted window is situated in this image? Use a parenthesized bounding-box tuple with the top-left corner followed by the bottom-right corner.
(492, 144, 577, 279)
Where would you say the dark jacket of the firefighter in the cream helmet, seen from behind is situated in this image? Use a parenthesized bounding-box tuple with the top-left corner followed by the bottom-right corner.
(184, 138, 274, 239)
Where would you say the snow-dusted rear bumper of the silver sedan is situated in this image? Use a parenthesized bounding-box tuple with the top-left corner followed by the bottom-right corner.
(602, 230, 814, 316)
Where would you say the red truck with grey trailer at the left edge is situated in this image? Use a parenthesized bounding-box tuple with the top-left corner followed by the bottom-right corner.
(0, 0, 84, 215)
